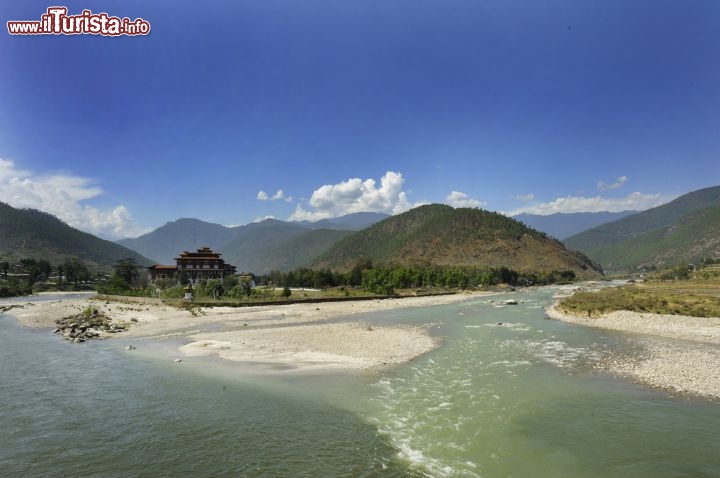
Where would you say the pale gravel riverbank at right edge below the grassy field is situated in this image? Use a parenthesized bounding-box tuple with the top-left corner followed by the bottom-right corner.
(546, 302, 720, 399)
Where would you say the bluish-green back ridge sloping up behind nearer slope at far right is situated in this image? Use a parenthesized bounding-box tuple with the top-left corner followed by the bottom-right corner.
(563, 186, 720, 252)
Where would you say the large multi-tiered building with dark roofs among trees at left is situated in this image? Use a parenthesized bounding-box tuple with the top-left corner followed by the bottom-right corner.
(148, 246, 236, 285)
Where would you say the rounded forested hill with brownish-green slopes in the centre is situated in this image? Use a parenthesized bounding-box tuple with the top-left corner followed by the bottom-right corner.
(313, 204, 601, 278)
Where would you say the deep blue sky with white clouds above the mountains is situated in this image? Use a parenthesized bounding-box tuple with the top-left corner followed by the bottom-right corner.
(0, 0, 720, 237)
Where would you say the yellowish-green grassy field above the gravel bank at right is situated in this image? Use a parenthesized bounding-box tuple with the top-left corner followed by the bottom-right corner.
(560, 268, 720, 317)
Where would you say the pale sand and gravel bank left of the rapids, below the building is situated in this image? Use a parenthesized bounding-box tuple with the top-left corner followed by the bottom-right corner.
(7, 293, 490, 370)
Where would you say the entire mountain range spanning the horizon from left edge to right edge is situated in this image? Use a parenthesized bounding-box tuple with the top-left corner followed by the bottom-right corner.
(5, 186, 720, 276)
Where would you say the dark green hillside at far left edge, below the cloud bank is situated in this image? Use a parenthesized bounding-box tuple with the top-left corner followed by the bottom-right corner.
(0, 202, 151, 267)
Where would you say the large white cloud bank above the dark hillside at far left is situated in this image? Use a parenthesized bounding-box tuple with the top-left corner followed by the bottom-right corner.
(0, 158, 149, 239)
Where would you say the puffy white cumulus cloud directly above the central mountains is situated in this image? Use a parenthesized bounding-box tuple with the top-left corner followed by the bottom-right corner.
(290, 171, 415, 221)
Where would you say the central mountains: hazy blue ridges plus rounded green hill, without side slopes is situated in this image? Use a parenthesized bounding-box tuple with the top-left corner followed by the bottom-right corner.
(119, 204, 599, 277)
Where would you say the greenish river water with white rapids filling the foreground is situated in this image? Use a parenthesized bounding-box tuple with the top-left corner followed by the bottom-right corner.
(0, 288, 720, 478)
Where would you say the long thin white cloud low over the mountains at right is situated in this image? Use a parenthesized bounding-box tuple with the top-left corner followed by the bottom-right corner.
(506, 192, 674, 216)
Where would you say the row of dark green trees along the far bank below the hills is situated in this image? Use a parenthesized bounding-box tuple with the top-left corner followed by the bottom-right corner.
(0, 257, 575, 299)
